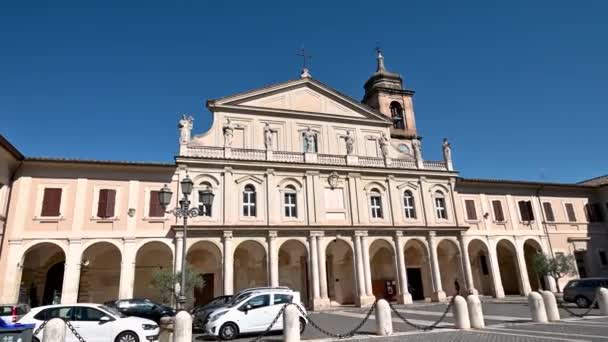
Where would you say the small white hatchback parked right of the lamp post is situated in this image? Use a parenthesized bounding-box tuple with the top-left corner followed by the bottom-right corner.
(205, 288, 308, 340)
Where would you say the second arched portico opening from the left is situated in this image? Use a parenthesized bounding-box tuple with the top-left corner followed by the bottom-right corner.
(78, 241, 122, 303)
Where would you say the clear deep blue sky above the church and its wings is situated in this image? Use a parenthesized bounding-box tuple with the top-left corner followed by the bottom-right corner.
(0, 0, 608, 182)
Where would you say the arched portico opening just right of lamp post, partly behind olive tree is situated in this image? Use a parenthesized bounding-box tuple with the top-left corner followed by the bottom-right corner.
(186, 240, 223, 306)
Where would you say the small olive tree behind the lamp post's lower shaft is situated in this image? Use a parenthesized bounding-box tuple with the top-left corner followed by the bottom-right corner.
(150, 263, 205, 304)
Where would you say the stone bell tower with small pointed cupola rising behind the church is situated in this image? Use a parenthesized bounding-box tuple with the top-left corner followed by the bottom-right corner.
(361, 48, 417, 139)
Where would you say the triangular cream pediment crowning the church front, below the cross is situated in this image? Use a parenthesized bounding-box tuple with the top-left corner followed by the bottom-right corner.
(214, 78, 390, 123)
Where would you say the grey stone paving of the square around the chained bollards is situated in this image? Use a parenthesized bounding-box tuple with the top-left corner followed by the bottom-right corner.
(194, 299, 608, 342)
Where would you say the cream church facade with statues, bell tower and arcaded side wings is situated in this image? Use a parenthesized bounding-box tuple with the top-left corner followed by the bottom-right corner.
(0, 53, 608, 309)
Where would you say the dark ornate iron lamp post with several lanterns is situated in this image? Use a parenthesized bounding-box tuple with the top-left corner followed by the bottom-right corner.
(158, 175, 214, 309)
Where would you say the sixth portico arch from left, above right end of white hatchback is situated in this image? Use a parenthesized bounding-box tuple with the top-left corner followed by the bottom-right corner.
(278, 240, 309, 305)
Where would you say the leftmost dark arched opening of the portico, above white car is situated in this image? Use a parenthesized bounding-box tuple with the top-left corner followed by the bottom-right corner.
(18, 242, 66, 307)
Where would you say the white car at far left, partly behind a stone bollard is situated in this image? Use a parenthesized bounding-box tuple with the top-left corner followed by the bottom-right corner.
(19, 303, 159, 342)
